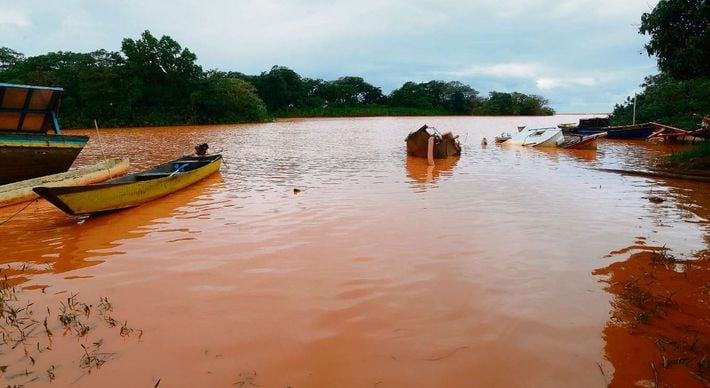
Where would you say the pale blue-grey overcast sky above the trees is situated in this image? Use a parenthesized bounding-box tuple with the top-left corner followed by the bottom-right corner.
(0, 0, 657, 112)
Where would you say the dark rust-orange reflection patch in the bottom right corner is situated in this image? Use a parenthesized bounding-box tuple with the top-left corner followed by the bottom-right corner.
(595, 247, 710, 387)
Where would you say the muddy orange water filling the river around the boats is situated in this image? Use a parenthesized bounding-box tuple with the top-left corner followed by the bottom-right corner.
(0, 116, 710, 387)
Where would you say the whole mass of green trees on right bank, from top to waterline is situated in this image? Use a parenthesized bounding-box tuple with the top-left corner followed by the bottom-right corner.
(610, 0, 710, 129)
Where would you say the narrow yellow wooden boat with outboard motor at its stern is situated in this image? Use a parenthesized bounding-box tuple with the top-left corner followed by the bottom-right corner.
(34, 154, 222, 215)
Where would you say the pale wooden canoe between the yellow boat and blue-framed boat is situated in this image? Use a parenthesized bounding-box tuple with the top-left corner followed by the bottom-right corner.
(0, 158, 128, 207)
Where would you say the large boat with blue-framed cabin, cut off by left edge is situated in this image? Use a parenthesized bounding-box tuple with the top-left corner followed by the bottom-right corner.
(0, 83, 89, 184)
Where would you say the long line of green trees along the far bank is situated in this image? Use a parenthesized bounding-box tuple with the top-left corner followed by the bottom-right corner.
(0, 30, 554, 128)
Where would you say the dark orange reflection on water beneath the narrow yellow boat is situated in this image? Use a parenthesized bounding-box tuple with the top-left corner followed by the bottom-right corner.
(0, 174, 222, 279)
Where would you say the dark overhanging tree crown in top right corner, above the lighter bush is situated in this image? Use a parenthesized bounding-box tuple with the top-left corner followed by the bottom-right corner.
(639, 0, 710, 79)
